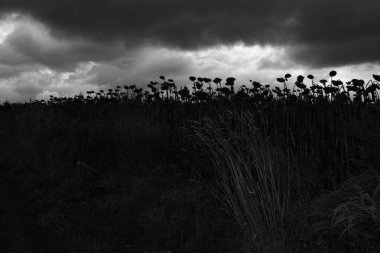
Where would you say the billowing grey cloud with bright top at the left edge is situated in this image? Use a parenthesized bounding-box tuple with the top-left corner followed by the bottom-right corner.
(0, 21, 124, 71)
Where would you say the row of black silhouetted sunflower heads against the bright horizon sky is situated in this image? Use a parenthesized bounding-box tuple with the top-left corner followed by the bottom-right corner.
(27, 71, 380, 104)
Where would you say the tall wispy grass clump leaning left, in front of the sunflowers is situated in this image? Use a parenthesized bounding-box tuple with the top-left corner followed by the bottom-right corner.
(193, 113, 291, 252)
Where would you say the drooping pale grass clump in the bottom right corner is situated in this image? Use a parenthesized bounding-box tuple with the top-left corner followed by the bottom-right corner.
(310, 171, 380, 252)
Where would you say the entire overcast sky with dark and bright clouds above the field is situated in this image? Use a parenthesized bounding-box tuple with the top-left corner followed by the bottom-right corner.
(0, 0, 380, 102)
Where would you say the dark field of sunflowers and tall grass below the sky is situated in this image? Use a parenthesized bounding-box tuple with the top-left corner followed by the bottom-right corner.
(0, 71, 380, 253)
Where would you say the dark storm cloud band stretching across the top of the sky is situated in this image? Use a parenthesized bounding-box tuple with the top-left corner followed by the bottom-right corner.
(0, 0, 380, 67)
